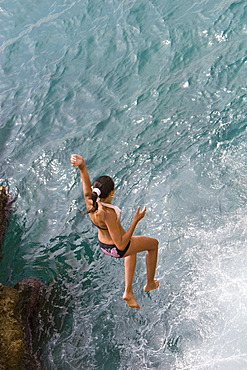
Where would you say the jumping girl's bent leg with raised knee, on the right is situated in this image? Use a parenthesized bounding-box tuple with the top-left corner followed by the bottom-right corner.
(125, 236, 159, 292)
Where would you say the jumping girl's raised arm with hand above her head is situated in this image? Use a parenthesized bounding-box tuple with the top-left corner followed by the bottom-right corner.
(70, 154, 92, 209)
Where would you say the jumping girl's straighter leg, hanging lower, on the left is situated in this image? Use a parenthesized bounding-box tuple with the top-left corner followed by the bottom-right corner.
(123, 254, 140, 308)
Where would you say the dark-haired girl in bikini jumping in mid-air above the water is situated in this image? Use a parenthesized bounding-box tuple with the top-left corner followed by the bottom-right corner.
(70, 154, 159, 308)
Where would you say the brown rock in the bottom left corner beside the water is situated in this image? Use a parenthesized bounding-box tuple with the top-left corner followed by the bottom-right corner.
(0, 278, 44, 370)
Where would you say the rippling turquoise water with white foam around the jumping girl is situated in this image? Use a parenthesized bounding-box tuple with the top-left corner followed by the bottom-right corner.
(0, 0, 247, 370)
